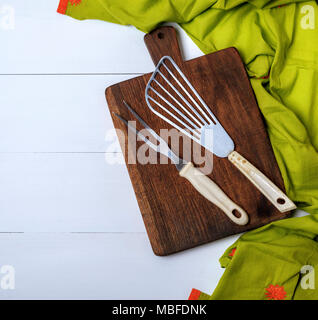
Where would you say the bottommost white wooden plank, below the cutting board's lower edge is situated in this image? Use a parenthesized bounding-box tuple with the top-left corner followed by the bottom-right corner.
(0, 234, 237, 299)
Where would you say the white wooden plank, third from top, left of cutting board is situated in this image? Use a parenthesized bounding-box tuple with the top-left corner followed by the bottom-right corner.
(0, 153, 145, 232)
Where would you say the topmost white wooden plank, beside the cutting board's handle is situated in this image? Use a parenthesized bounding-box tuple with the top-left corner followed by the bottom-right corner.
(0, 0, 201, 74)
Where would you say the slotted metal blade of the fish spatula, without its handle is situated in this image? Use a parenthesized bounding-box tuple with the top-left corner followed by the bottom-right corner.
(145, 56, 235, 158)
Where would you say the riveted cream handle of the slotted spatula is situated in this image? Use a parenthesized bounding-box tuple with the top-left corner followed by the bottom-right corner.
(228, 151, 296, 212)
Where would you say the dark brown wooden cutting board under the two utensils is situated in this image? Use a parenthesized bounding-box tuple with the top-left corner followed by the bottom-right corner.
(106, 27, 289, 256)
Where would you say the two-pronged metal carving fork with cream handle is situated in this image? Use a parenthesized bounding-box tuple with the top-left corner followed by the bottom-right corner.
(115, 101, 248, 225)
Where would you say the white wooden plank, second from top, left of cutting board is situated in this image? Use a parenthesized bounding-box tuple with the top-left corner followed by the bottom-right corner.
(0, 75, 133, 152)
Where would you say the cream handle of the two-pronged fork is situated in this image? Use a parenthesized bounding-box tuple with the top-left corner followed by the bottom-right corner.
(180, 162, 249, 226)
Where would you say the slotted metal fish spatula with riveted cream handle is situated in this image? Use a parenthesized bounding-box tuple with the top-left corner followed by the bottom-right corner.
(145, 56, 296, 212)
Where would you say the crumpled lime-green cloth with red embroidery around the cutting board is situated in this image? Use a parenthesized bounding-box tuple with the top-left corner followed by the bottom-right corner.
(58, 0, 318, 299)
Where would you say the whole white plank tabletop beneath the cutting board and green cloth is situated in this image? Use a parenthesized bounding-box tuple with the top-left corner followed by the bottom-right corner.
(0, 0, 306, 299)
